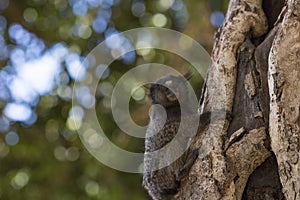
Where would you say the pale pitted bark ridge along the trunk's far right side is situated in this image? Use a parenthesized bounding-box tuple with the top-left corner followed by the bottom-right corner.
(269, 0, 300, 199)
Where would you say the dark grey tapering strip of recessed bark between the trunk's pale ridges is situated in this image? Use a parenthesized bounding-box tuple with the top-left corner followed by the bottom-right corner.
(228, 37, 267, 137)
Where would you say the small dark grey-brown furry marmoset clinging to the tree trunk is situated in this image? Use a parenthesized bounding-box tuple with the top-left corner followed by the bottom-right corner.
(143, 75, 205, 200)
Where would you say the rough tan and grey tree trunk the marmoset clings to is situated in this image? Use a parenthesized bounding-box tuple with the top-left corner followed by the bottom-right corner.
(175, 0, 300, 200)
